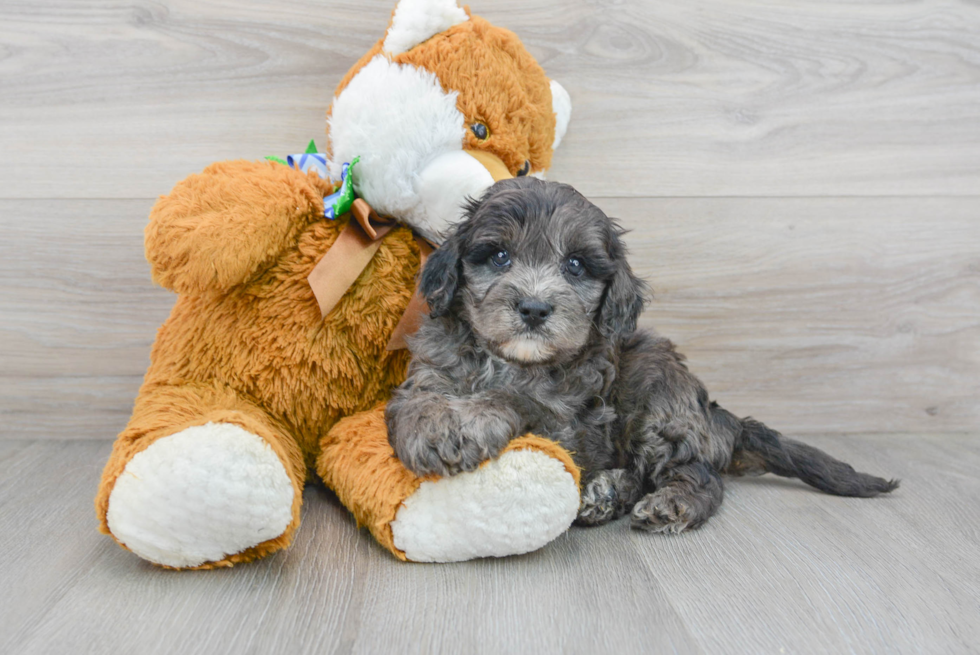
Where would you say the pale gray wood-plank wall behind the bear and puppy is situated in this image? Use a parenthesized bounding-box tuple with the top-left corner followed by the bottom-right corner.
(0, 0, 980, 439)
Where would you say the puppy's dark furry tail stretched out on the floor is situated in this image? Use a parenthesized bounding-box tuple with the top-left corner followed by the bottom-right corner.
(711, 403, 898, 498)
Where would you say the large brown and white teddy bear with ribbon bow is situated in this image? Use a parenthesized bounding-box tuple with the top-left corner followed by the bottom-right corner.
(96, 0, 579, 568)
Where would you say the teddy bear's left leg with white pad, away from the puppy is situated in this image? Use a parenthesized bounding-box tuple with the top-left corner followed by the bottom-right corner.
(95, 385, 306, 568)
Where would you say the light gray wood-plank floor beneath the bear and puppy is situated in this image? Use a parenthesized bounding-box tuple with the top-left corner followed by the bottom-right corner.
(0, 434, 980, 655)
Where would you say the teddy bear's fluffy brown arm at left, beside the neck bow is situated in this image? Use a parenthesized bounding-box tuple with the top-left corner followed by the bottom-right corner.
(145, 160, 332, 293)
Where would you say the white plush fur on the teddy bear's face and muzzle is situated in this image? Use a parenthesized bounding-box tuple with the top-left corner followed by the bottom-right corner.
(330, 55, 480, 243)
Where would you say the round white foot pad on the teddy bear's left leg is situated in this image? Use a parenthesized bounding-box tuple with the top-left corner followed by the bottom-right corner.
(106, 423, 294, 568)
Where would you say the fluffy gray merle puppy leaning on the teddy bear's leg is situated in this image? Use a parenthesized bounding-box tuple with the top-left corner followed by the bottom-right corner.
(386, 177, 898, 532)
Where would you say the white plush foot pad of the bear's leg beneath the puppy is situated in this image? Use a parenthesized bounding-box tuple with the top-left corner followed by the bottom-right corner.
(391, 450, 579, 562)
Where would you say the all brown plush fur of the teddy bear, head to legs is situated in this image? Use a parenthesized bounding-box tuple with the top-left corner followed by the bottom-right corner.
(96, 5, 578, 568)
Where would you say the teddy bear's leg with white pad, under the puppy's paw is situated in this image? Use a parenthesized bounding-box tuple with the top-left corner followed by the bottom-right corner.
(317, 405, 579, 562)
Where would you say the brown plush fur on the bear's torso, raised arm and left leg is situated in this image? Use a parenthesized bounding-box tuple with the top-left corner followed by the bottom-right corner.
(96, 162, 419, 562)
